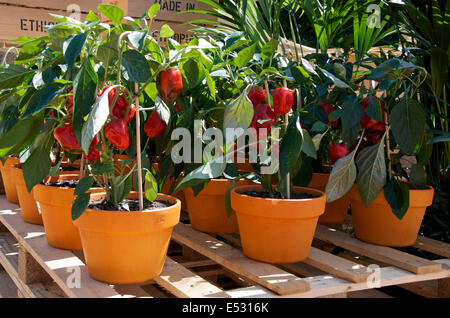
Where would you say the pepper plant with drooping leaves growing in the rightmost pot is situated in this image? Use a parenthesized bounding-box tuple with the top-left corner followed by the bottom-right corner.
(326, 58, 431, 219)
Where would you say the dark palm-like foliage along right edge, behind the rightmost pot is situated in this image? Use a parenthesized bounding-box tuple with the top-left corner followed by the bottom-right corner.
(389, 0, 450, 242)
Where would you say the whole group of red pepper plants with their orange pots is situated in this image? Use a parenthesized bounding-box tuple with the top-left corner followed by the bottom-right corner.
(0, 4, 433, 283)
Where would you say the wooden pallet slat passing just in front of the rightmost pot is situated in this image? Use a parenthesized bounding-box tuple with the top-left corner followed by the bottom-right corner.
(315, 225, 442, 274)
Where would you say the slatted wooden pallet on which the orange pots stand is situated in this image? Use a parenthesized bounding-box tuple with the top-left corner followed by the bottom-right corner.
(0, 196, 450, 298)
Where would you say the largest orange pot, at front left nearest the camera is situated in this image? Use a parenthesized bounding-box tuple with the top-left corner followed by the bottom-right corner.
(74, 193, 181, 284)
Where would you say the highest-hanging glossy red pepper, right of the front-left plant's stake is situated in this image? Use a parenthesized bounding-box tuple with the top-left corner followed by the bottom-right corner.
(156, 67, 183, 104)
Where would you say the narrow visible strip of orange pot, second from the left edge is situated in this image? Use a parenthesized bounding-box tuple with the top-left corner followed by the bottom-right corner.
(10, 165, 43, 225)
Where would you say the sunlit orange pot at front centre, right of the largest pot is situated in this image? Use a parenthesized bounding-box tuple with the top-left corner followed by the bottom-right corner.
(231, 185, 326, 264)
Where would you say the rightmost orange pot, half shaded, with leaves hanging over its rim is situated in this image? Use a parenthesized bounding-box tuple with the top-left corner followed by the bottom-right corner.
(350, 187, 434, 247)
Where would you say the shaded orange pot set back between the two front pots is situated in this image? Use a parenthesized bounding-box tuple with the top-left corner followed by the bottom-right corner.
(183, 179, 253, 233)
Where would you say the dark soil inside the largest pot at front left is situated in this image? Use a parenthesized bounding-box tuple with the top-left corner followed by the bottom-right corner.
(89, 199, 173, 212)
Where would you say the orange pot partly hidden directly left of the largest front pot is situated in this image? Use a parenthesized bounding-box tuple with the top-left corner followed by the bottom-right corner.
(33, 174, 97, 250)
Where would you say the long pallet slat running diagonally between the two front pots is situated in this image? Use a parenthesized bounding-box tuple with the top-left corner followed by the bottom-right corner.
(172, 224, 309, 295)
